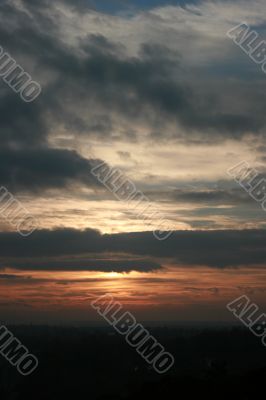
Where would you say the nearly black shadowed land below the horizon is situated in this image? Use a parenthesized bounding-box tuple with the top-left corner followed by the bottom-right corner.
(0, 326, 266, 400)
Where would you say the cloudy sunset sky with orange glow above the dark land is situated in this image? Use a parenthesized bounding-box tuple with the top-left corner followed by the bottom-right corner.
(0, 0, 266, 323)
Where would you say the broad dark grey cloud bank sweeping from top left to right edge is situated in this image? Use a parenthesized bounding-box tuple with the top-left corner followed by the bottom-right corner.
(0, 1, 265, 152)
